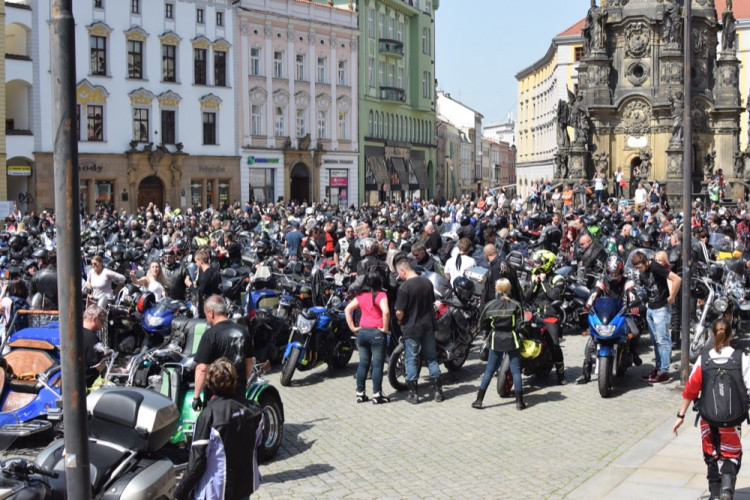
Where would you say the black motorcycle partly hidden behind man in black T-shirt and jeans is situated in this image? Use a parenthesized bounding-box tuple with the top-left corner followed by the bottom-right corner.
(388, 272, 480, 391)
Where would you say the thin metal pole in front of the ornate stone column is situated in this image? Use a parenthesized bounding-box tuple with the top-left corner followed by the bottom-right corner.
(680, 0, 693, 385)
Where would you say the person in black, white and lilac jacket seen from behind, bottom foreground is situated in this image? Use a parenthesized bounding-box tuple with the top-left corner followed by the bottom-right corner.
(174, 358, 263, 500)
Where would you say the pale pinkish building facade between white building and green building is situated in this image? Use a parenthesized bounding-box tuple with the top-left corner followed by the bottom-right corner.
(236, 0, 360, 206)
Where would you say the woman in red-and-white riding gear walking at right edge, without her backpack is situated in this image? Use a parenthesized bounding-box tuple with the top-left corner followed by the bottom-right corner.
(672, 318, 750, 499)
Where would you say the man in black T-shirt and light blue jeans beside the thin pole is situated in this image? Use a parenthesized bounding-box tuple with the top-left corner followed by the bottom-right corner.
(632, 251, 682, 384)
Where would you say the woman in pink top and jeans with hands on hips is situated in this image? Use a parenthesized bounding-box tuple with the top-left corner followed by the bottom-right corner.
(344, 271, 391, 404)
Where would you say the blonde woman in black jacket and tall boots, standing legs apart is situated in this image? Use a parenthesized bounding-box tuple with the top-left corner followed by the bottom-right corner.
(471, 278, 526, 410)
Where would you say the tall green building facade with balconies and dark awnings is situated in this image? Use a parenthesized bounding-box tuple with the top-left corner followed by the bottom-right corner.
(352, 0, 444, 203)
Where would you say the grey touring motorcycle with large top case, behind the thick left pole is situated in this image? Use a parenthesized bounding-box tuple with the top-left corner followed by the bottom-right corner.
(0, 387, 178, 500)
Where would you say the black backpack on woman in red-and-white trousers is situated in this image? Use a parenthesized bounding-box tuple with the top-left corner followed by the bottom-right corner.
(695, 350, 750, 427)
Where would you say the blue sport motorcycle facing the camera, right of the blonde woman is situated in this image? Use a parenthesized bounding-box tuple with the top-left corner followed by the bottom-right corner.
(587, 297, 637, 398)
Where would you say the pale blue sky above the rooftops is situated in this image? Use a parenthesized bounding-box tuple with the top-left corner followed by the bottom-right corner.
(435, 0, 600, 125)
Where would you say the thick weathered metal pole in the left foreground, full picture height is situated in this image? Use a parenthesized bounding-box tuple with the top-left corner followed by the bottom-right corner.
(50, 0, 91, 500)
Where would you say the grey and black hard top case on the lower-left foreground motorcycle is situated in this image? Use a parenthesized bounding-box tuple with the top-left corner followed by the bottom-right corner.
(86, 387, 180, 452)
